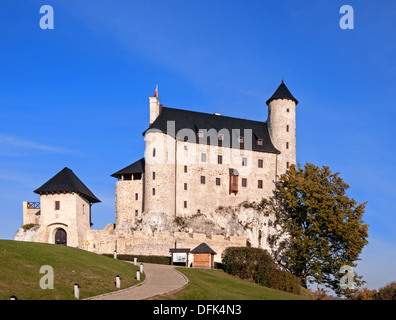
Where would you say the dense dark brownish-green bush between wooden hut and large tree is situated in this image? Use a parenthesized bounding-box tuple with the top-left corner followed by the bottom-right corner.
(222, 247, 301, 294)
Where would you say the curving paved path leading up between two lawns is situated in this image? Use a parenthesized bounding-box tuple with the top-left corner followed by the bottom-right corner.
(87, 263, 188, 300)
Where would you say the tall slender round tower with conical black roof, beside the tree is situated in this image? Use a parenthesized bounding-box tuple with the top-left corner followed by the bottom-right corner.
(267, 80, 298, 175)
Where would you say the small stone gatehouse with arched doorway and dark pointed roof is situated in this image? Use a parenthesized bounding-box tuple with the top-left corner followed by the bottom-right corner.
(15, 168, 100, 248)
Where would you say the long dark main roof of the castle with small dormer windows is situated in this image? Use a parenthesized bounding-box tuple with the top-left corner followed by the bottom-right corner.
(143, 107, 280, 154)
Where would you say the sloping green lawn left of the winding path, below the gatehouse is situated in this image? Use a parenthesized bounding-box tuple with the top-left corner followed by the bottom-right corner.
(0, 240, 143, 300)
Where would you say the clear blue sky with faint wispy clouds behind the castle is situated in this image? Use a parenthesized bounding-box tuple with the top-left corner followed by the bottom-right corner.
(0, 0, 396, 288)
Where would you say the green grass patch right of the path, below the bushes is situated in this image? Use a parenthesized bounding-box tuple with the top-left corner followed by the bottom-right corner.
(153, 267, 311, 300)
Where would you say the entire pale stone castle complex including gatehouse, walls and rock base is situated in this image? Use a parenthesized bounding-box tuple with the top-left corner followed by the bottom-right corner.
(15, 80, 298, 261)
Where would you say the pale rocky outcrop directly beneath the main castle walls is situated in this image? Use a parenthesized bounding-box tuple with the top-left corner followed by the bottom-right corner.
(116, 202, 281, 254)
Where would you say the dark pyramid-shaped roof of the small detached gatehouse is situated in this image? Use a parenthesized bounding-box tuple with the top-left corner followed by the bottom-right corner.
(34, 168, 100, 203)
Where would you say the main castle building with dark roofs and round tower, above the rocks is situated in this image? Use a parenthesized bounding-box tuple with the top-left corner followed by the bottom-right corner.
(112, 80, 298, 226)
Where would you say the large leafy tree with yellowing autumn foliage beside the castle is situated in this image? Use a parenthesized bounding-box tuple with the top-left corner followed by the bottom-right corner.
(270, 163, 368, 294)
